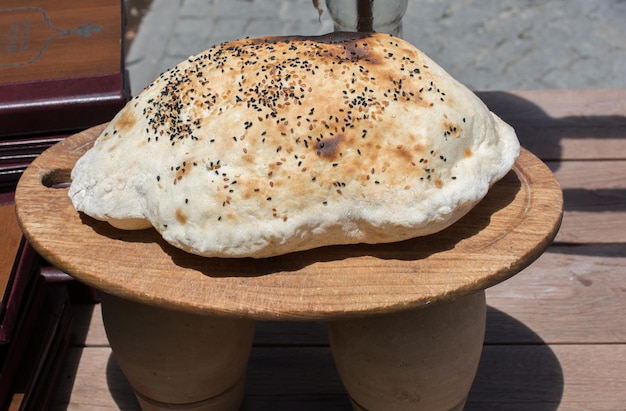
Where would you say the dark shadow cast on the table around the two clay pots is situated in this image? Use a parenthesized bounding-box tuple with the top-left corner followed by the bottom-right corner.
(101, 307, 564, 411)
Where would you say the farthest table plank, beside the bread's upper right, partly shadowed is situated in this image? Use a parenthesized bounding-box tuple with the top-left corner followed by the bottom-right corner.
(478, 90, 626, 160)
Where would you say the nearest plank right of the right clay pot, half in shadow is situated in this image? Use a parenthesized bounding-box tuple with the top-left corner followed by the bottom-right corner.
(465, 344, 626, 411)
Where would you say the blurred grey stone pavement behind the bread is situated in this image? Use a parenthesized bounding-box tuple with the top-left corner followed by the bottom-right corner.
(127, 0, 626, 94)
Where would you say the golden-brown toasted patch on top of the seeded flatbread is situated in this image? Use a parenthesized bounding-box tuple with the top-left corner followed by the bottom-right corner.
(143, 34, 463, 203)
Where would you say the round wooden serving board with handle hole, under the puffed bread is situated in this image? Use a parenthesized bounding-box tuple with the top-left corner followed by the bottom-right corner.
(15, 126, 563, 319)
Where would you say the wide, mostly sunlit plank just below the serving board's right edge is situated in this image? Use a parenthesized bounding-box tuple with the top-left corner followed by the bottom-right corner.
(485, 245, 626, 344)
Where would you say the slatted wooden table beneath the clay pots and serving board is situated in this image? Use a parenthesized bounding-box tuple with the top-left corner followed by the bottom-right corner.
(19, 91, 626, 410)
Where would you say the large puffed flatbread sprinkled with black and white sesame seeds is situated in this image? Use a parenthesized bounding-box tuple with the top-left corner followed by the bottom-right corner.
(69, 33, 519, 258)
